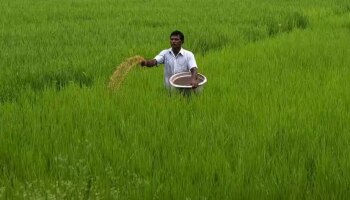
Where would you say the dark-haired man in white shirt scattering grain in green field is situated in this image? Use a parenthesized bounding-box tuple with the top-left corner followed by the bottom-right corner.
(140, 31, 198, 88)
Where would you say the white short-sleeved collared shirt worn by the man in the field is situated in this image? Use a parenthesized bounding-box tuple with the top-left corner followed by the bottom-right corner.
(154, 48, 197, 87)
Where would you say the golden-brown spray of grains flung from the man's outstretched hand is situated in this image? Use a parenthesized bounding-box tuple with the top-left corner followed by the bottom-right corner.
(108, 56, 144, 90)
